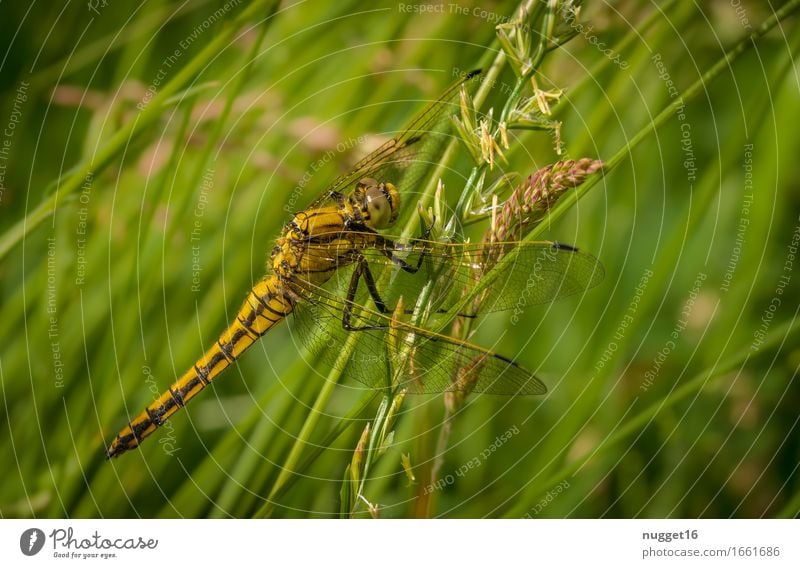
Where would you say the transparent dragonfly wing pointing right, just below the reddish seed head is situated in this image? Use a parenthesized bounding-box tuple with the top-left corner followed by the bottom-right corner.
(306, 231, 604, 316)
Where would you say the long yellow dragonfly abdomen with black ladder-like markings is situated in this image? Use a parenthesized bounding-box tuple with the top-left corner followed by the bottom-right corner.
(107, 276, 293, 457)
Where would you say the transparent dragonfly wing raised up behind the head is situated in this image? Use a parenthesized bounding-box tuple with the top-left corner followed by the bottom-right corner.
(300, 71, 480, 209)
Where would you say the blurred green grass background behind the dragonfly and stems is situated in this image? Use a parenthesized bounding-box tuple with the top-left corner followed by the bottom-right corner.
(0, 0, 800, 518)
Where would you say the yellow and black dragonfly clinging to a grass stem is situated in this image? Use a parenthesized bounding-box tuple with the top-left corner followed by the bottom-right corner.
(106, 71, 603, 458)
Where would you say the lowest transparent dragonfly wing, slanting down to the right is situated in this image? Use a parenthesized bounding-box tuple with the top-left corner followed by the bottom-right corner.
(284, 276, 547, 395)
